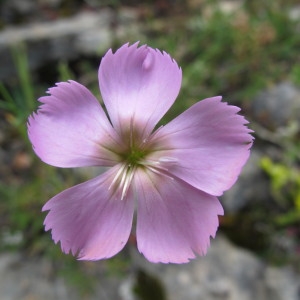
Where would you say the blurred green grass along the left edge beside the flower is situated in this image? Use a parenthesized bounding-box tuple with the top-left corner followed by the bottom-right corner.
(0, 45, 105, 295)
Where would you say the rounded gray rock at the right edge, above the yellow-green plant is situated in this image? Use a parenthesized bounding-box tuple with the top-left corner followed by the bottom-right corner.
(251, 82, 300, 129)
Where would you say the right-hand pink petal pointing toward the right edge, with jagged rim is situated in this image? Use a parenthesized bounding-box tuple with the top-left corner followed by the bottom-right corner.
(149, 97, 253, 196)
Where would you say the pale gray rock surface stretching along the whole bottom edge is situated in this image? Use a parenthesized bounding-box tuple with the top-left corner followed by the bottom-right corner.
(0, 234, 300, 300)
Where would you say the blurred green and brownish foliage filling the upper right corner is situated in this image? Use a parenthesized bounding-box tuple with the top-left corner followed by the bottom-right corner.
(142, 1, 300, 113)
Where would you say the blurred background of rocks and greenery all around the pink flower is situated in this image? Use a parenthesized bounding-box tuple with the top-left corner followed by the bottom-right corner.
(0, 0, 300, 300)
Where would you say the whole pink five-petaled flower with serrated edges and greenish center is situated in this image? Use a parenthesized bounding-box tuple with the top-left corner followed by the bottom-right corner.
(28, 44, 252, 263)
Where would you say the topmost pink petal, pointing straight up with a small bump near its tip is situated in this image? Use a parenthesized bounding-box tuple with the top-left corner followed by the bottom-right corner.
(99, 43, 182, 136)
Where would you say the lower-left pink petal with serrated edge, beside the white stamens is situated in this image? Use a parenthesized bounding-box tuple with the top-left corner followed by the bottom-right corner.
(43, 168, 134, 260)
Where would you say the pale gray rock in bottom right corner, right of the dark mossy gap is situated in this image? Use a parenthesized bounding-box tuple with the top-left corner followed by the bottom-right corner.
(124, 235, 300, 300)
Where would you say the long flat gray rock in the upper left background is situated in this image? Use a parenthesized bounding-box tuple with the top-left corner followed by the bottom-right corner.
(0, 9, 113, 80)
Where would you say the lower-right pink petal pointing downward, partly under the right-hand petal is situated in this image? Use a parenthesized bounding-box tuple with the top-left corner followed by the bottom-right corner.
(134, 169, 223, 263)
